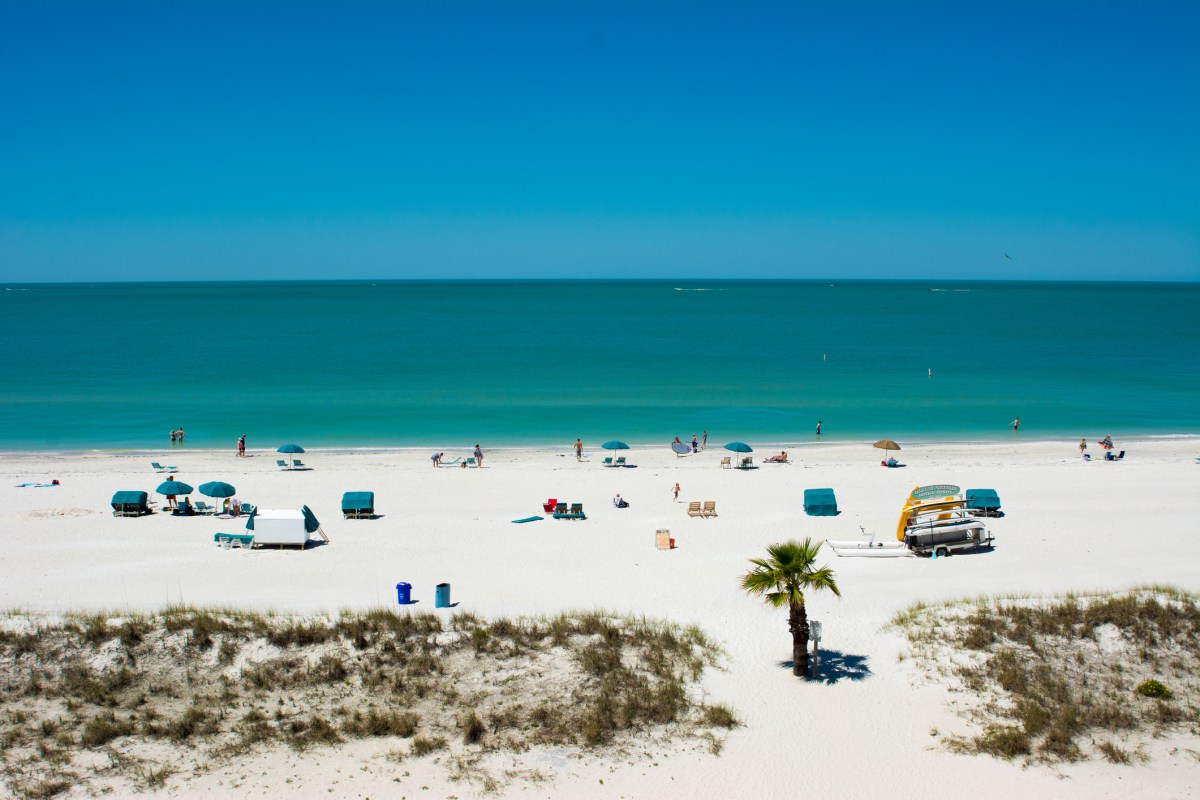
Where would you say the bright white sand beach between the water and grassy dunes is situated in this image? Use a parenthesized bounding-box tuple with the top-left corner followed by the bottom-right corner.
(0, 438, 1200, 800)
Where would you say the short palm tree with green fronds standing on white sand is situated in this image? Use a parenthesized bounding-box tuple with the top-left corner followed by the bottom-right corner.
(742, 537, 841, 675)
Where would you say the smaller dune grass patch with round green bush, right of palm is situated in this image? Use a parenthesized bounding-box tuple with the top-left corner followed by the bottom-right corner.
(892, 587, 1200, 764)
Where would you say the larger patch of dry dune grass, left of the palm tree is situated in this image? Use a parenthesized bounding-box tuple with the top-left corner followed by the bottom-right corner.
(0, 607, 738, 798)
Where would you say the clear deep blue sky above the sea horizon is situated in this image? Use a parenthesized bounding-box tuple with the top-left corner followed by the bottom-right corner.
(0, 0, 1200, 282)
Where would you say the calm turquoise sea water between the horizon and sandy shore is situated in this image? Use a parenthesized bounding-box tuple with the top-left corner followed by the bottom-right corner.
(0, 281, 1200, 450)
